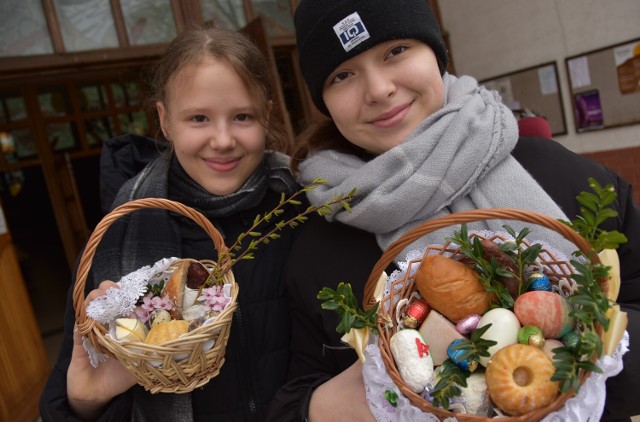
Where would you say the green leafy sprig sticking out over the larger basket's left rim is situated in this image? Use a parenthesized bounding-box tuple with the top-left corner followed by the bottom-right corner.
(318, 282, 379, 335)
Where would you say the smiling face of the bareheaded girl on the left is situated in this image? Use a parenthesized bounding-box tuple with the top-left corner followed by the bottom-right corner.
(156, 58, 266, 196)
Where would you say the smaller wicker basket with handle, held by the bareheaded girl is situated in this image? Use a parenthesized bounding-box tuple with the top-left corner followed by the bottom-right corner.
(73, 198, 238, 393)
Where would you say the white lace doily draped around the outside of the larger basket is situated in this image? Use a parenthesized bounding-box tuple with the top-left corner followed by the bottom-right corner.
(362, 331, 629, 422)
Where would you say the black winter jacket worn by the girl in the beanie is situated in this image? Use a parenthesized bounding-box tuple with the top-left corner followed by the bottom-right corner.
(270, 138, 640, 421)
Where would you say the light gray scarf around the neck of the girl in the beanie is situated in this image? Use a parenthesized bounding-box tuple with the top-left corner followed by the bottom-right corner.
(299, 74, 574, 258)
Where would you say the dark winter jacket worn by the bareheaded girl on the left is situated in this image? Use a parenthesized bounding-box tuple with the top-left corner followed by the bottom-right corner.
(40, 134, 295, 421)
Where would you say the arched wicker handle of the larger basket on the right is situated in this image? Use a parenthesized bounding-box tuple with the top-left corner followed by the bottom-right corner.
(363, 208, 606, 309)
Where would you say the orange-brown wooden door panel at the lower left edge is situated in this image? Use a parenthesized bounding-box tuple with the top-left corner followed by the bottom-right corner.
(0, 199, 49, 421)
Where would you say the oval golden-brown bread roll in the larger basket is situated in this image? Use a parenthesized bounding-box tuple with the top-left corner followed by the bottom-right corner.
(415, 255, 495, 323)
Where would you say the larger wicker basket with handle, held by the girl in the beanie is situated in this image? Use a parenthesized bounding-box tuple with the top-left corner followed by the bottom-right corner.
(364, 208, 607, 421)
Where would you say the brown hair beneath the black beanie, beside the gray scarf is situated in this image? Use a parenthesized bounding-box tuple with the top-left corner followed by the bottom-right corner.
(291, 118, 370, 172)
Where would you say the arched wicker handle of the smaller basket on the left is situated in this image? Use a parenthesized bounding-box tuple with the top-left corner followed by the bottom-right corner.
(73, 198, 228, 334)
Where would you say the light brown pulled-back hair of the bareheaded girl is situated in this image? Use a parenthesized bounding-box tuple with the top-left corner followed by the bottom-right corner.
(146, 26, 288, 151)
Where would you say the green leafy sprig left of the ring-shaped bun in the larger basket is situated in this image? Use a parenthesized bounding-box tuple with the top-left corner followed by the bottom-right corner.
(430, 324, 497, 409)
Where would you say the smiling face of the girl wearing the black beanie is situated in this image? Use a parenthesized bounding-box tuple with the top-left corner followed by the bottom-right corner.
(323, 40, 444, 154)
